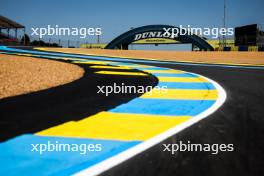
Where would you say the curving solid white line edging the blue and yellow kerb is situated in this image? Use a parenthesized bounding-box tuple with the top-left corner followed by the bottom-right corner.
(74, 70, 226, 176)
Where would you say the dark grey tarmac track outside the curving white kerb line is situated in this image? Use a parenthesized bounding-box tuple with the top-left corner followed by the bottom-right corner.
(102, 64, 264, 176)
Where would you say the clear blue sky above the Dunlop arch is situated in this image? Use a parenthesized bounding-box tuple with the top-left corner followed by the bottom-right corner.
(0, 0, 264, 42)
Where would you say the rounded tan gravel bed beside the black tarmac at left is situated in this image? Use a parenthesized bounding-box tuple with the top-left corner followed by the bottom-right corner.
(0, 54, 84, 99)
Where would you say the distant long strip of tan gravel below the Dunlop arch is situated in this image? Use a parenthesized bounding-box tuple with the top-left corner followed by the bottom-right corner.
(36, 48, 264, 65)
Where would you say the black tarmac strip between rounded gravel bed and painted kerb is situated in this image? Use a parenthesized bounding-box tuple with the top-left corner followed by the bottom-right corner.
(0, 60, 157, 141)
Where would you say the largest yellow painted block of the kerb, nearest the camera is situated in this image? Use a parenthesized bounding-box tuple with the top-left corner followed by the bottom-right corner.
(37, 112, 191, 141)
